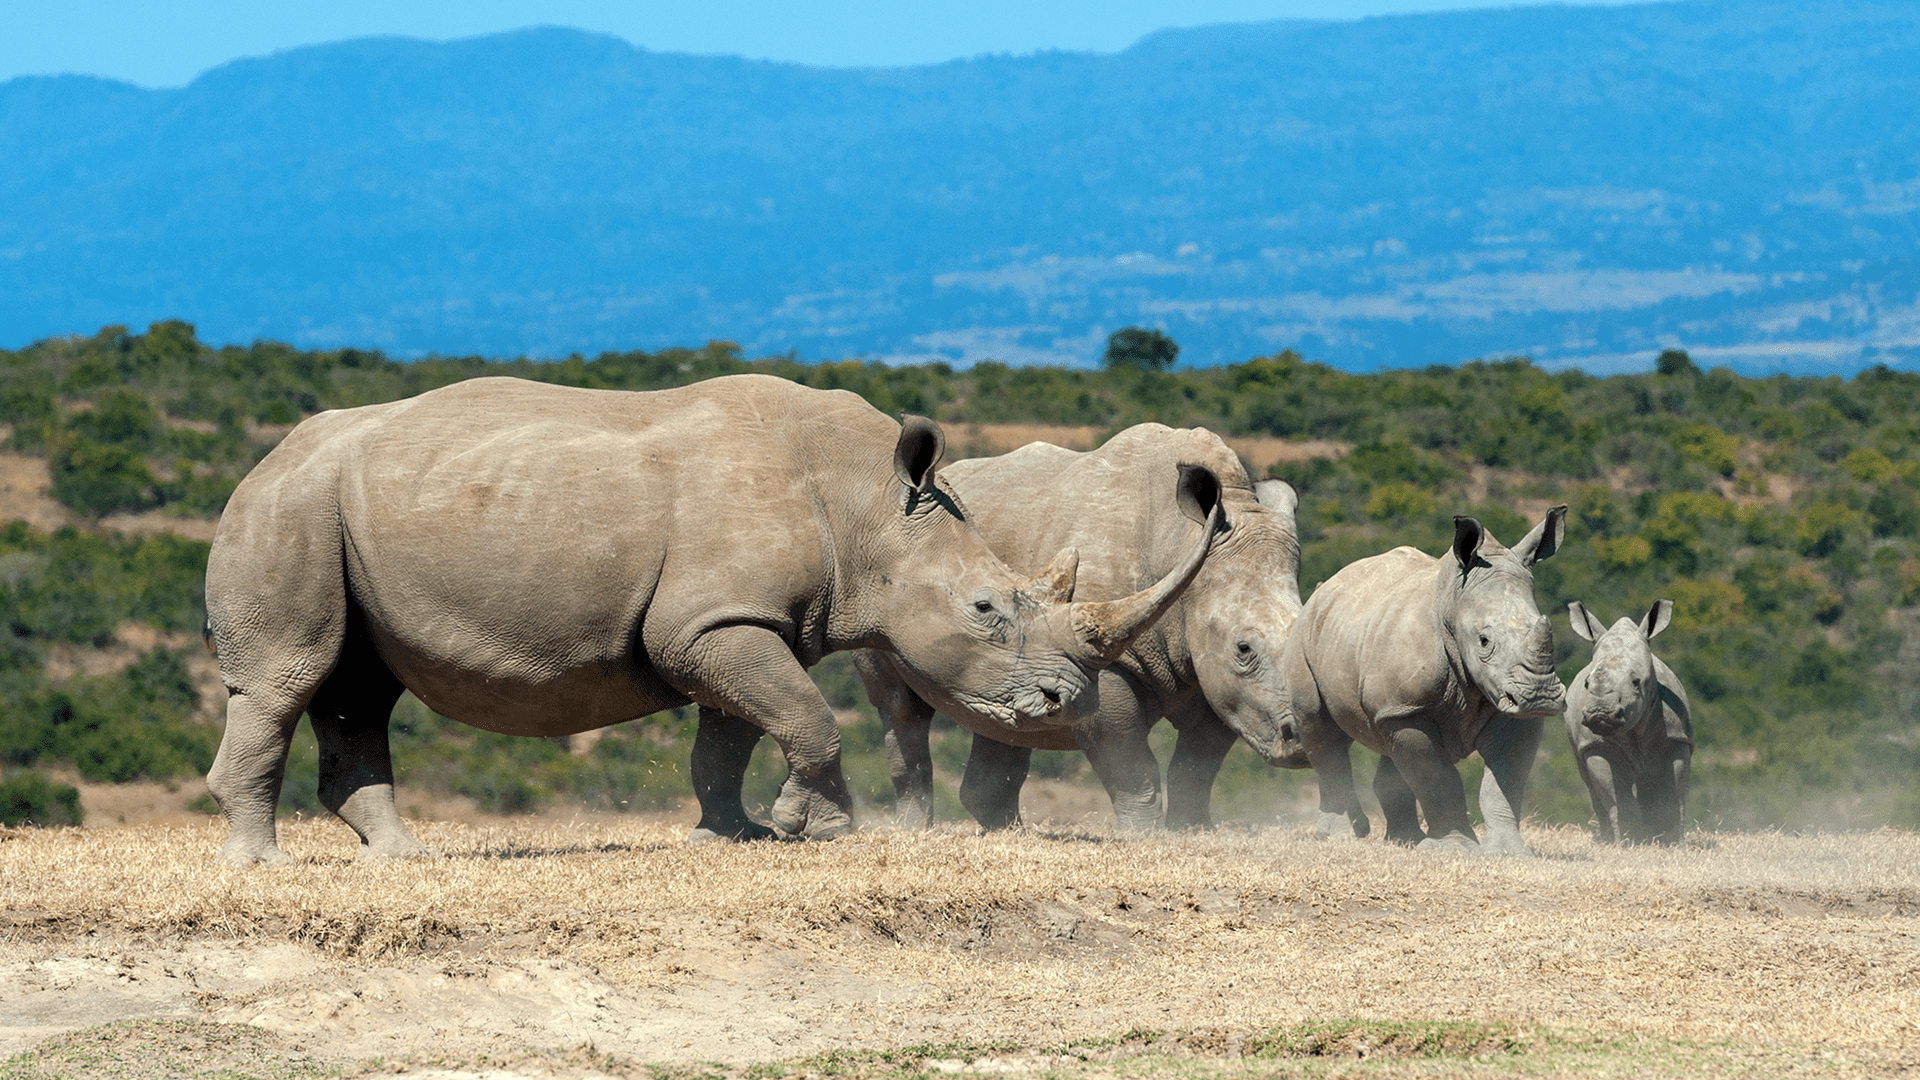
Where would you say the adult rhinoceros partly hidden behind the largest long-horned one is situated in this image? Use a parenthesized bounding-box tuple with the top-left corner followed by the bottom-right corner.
(854, 423, 1304, 828)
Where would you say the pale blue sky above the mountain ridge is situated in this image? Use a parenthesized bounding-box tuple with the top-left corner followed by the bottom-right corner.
(0, 0, 1651, 86)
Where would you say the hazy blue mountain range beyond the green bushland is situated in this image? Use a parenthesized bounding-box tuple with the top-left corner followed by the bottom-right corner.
(0, 0, 1920, 373)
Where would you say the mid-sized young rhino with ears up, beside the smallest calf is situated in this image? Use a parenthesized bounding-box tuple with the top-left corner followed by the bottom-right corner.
(1281, 505, 1567, 855)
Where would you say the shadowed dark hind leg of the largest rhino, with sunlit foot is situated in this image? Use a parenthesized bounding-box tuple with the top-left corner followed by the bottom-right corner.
(307, 626, 432, 859)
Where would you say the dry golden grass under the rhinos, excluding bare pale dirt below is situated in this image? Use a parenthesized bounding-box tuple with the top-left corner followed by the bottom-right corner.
(0, 822, 1920, 1067)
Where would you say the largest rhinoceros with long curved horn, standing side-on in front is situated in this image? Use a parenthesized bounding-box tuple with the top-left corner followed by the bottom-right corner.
(207, 375, 1208, 863)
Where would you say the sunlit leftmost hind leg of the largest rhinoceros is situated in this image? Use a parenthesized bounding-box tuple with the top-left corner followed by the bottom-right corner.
(207, 692, 301, 867)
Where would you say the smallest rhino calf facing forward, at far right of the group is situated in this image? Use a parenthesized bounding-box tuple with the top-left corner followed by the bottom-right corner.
(1567, 600, 1693, 844)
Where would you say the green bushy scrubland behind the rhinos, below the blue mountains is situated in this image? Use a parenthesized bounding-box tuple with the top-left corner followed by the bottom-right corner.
(0, 323, 1920, 828)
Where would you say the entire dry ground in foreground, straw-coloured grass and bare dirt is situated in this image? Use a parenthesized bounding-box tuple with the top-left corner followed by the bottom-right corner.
(0, 819, 1920, 1080)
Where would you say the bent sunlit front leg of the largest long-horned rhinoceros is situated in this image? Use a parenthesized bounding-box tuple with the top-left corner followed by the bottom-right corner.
(674, 625, 852, 840)
